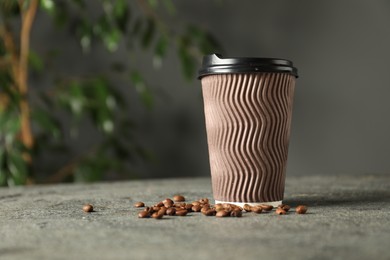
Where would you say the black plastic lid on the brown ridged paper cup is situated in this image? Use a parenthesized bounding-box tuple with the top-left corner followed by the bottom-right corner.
(198, 54, 298, 79)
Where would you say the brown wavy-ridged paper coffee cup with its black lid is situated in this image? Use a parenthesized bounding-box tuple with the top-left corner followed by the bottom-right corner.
(199, 54, 297, 206)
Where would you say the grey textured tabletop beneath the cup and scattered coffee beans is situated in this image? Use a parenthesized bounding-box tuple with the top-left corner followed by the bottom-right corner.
(0, 175, 390, 260)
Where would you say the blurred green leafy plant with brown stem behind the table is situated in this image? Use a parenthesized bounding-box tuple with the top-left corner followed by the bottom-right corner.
(0, 0, 220, 186)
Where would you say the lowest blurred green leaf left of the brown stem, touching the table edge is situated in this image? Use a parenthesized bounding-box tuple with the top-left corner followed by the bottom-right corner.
(7, 150, 27, 185)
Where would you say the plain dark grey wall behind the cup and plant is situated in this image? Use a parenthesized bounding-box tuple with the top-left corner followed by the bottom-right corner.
(33, 0, 390, 177)
